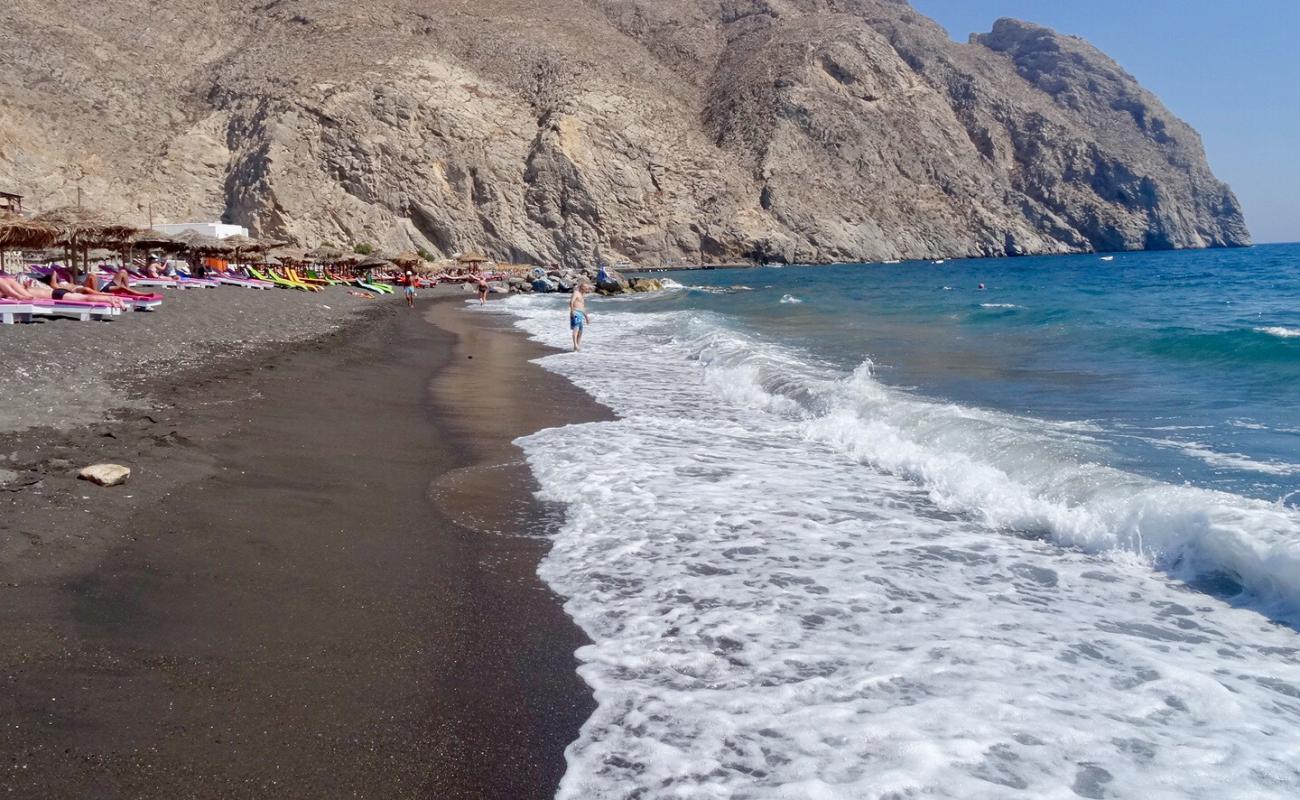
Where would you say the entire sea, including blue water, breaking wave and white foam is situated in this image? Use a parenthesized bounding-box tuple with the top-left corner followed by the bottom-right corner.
(495, 246, 1300, 800)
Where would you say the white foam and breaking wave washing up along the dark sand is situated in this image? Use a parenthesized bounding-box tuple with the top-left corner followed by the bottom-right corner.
(486, 298, 1300, 800)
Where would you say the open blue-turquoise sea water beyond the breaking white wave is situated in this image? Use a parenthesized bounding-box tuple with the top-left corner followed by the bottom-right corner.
(641, 245, 1300, 507)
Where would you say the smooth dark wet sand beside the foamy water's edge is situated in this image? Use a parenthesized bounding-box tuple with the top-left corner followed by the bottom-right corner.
(0, 295, 607, 799)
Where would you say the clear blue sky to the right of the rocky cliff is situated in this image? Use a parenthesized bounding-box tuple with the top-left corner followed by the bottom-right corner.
(911, 0, 1300, 242)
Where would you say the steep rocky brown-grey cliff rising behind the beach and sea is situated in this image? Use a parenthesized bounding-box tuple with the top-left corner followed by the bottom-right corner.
(0, 0, 1249, 263)
